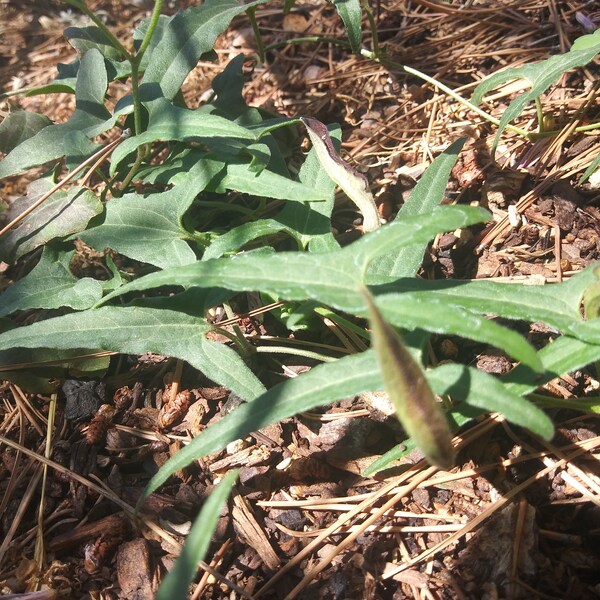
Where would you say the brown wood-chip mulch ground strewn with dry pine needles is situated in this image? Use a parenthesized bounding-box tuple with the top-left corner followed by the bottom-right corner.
(0, 0, 600, 600)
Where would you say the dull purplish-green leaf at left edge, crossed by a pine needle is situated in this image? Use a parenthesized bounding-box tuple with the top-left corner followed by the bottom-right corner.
(0, 179, 102, 262)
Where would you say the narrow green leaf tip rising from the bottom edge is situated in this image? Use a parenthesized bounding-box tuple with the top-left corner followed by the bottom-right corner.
(156, 471, 238, 600)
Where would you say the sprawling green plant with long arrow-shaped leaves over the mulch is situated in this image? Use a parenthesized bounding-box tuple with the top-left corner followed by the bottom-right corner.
(0, 0, 600, 592)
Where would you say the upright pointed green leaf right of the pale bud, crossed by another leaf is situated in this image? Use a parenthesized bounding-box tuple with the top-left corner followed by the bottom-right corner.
(367, 138, 465, 285)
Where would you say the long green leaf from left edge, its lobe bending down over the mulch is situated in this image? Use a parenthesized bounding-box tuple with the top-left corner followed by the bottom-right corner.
(0, 307, 264, 400)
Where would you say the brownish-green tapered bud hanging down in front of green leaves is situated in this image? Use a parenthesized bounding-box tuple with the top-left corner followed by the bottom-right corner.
(363, 289, 454, 469)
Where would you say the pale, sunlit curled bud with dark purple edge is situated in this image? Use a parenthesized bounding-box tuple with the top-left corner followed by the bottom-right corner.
(301, 117, 381, 233)
